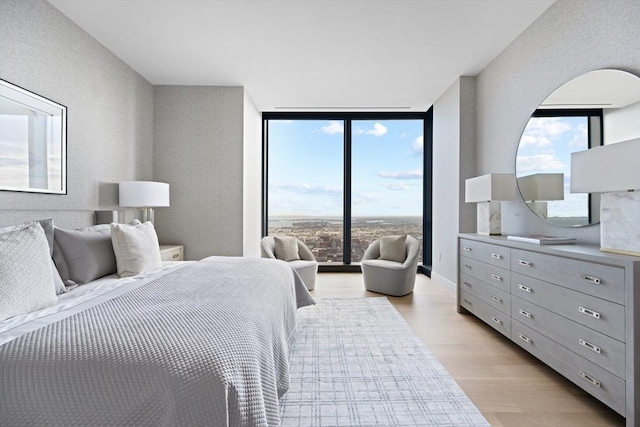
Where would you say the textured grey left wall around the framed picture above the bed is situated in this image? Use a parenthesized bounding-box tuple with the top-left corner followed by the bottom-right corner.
(0, 0, 153, 219)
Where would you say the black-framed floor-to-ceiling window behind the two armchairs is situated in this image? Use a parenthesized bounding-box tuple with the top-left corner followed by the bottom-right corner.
(263, 113, 431, 268)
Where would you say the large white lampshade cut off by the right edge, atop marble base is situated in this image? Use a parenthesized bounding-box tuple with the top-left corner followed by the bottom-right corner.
(571, 138, 640, 193)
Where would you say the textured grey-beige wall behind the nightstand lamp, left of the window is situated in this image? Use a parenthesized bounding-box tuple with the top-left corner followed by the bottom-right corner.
(153, 86, 244, 260)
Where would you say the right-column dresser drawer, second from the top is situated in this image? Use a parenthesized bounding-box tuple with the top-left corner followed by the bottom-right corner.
(511, 273, 626, 342)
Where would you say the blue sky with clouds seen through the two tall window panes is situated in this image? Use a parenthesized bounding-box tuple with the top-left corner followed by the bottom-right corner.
(268, 120, 423, 217)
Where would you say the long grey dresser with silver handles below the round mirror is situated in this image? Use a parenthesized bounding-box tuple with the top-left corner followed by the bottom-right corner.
(458, 234, 640, 426)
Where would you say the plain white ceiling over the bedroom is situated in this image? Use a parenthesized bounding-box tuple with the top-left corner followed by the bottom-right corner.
(49, 0, 554, 111)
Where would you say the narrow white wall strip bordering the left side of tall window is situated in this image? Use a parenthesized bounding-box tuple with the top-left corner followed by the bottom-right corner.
(242, 91, 262, 257)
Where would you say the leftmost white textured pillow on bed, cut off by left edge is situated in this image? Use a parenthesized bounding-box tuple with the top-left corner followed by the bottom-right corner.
(0, 222, 58, 321)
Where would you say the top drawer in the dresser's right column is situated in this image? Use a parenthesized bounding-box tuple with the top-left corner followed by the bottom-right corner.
(511, 249, 625, 304)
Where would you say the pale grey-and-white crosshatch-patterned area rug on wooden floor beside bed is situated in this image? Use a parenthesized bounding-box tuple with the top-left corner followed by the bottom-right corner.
(280, 298, 489, 427)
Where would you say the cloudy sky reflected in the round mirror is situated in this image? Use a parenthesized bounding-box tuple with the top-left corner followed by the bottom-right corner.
(516, 117, 588, 217)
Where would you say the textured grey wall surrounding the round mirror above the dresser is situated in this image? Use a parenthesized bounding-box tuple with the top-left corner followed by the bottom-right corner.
(476, 0, 640, 244)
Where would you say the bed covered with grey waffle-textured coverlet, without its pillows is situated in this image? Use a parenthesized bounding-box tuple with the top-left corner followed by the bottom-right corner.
(0, 219, 313, 426)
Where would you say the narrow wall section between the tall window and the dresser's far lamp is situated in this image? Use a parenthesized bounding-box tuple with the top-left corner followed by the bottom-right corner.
(431, 77, 476, 285)
